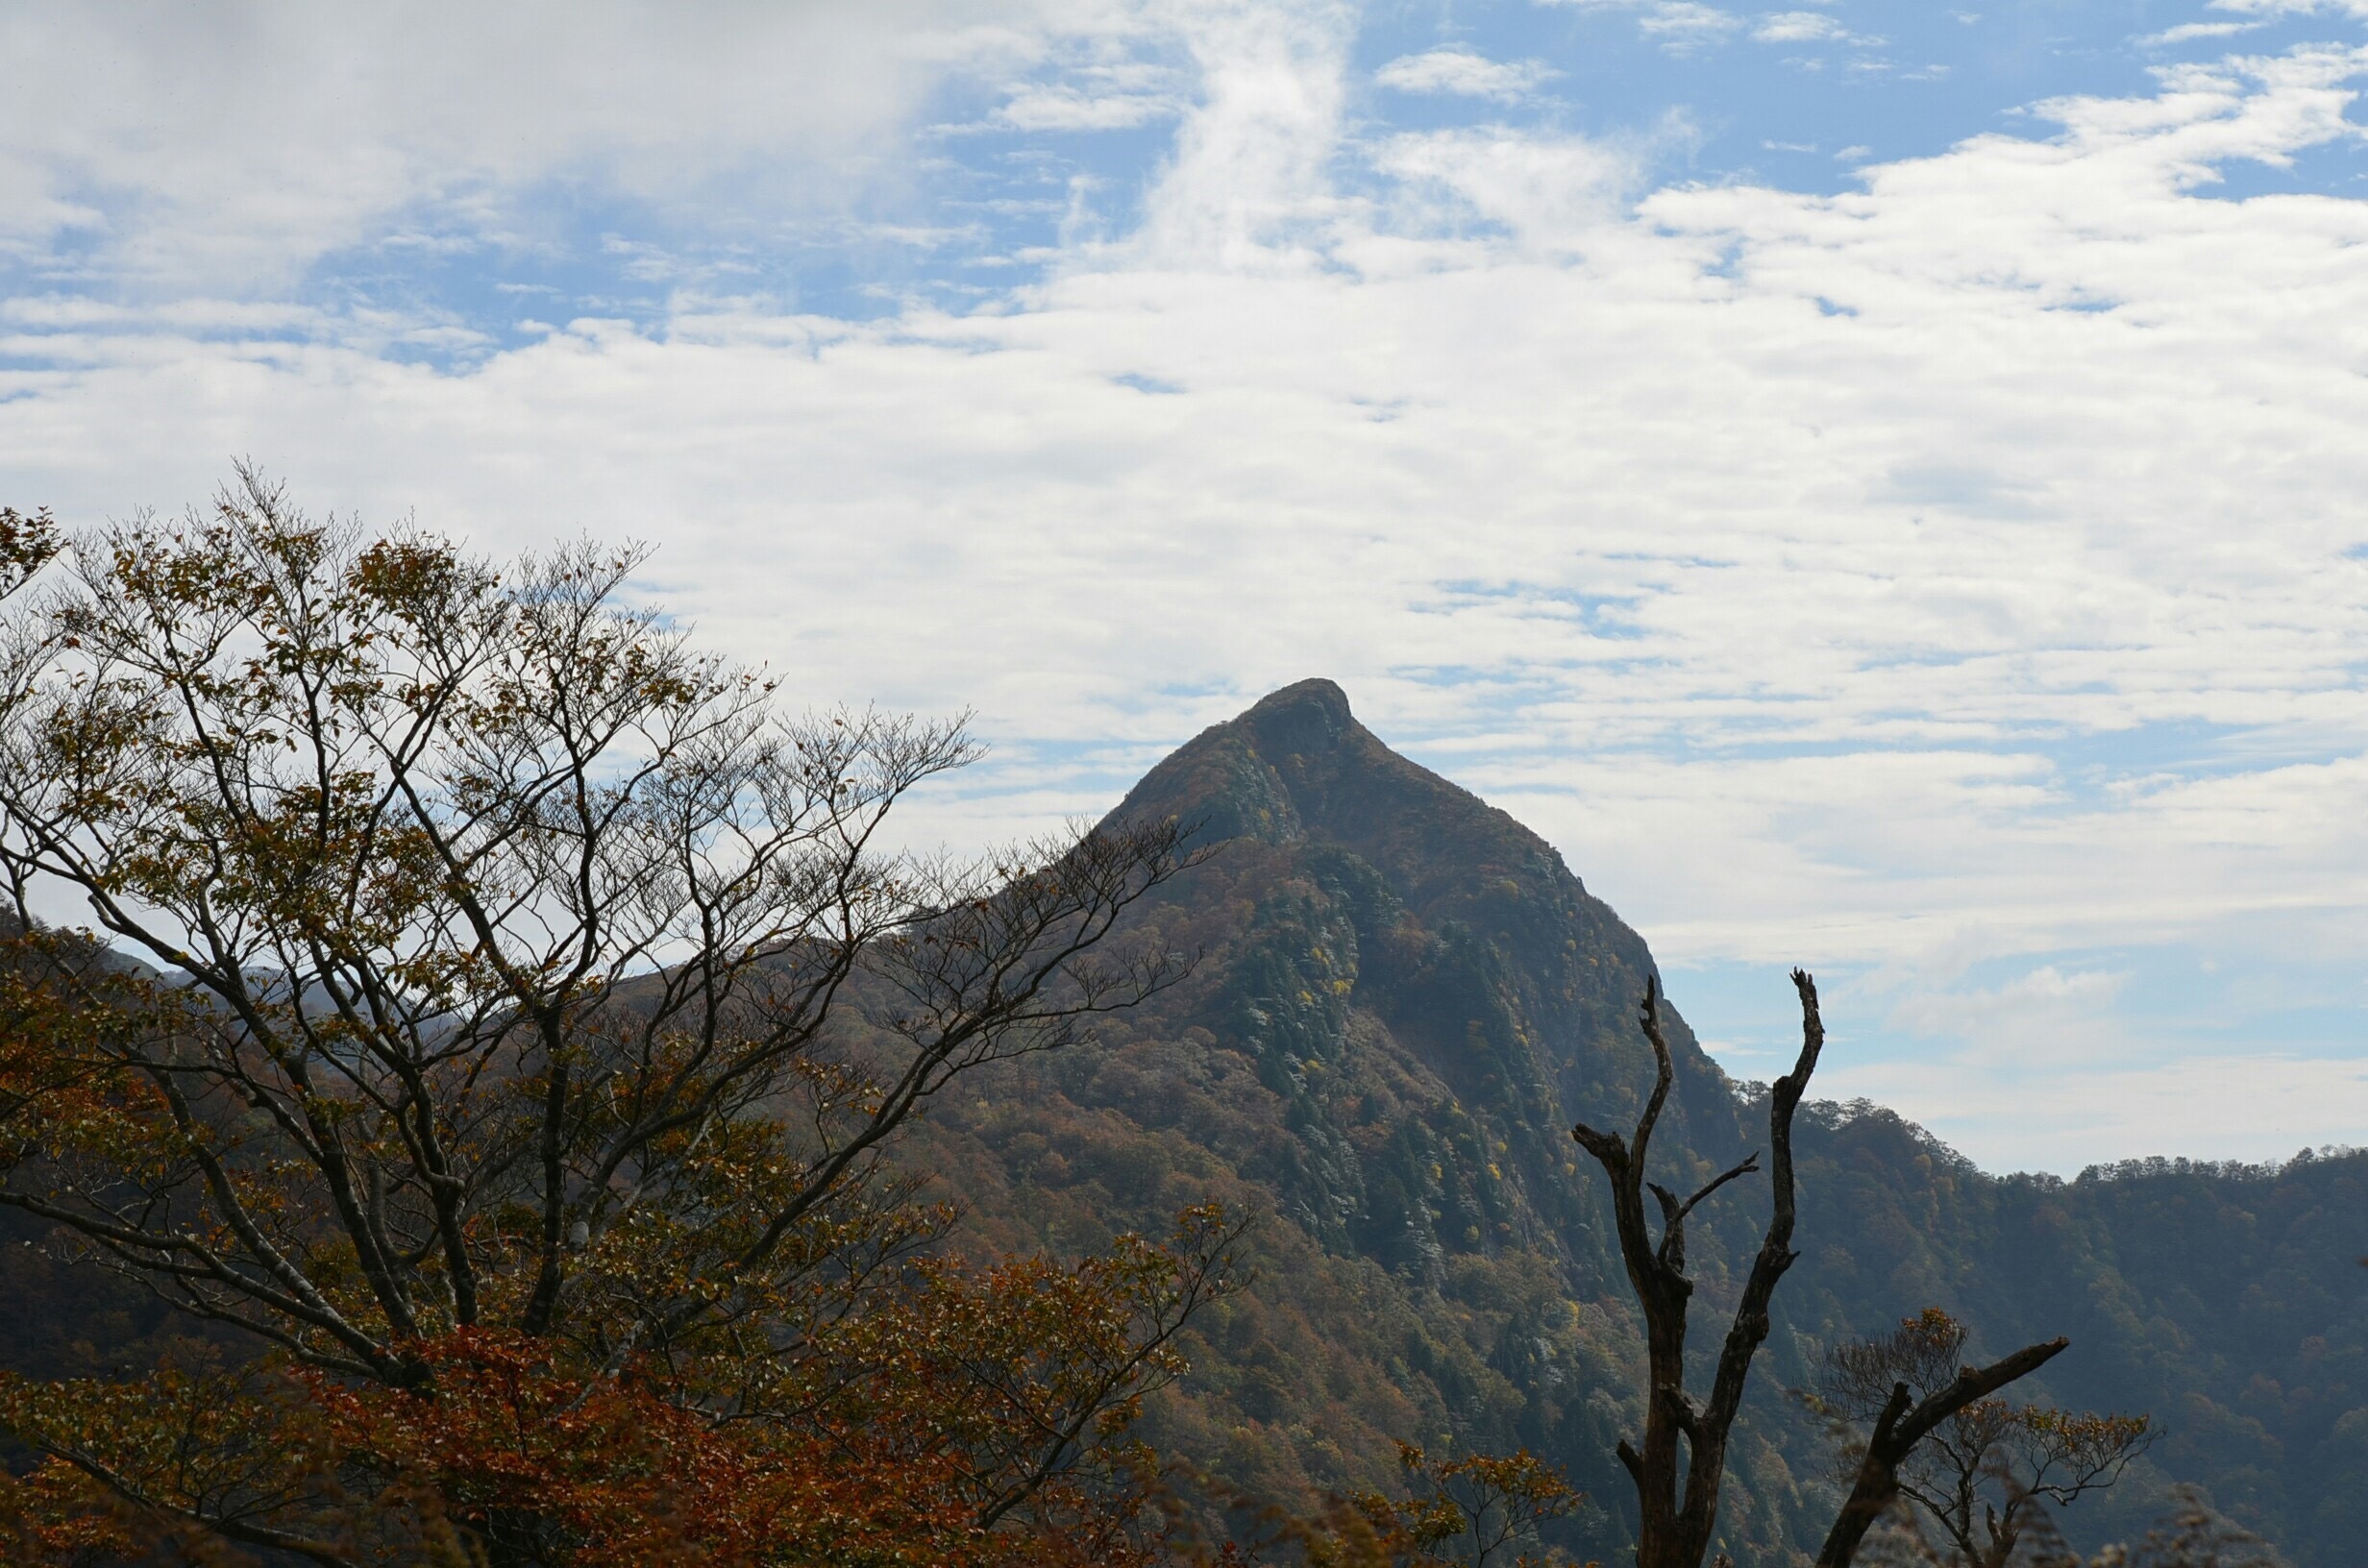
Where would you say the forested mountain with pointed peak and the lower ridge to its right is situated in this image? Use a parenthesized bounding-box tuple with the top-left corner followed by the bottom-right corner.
(912, 680, 2368, 1566)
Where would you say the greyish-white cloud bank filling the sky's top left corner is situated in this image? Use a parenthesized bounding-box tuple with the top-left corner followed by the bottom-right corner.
(0, 0, 1151, 291)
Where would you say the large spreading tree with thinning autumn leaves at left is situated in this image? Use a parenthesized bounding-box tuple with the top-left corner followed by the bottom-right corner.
(0, 469, 1234, 1563)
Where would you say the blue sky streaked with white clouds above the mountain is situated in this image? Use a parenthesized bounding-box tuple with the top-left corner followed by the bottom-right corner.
(0, 0, 2368, 1175)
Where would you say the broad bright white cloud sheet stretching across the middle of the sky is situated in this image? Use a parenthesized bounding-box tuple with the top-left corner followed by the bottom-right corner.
(0, 15, 2368, 1163)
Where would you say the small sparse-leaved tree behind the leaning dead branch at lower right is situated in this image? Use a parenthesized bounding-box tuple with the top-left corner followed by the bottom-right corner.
(1807, 1308, 2155, 1568)
